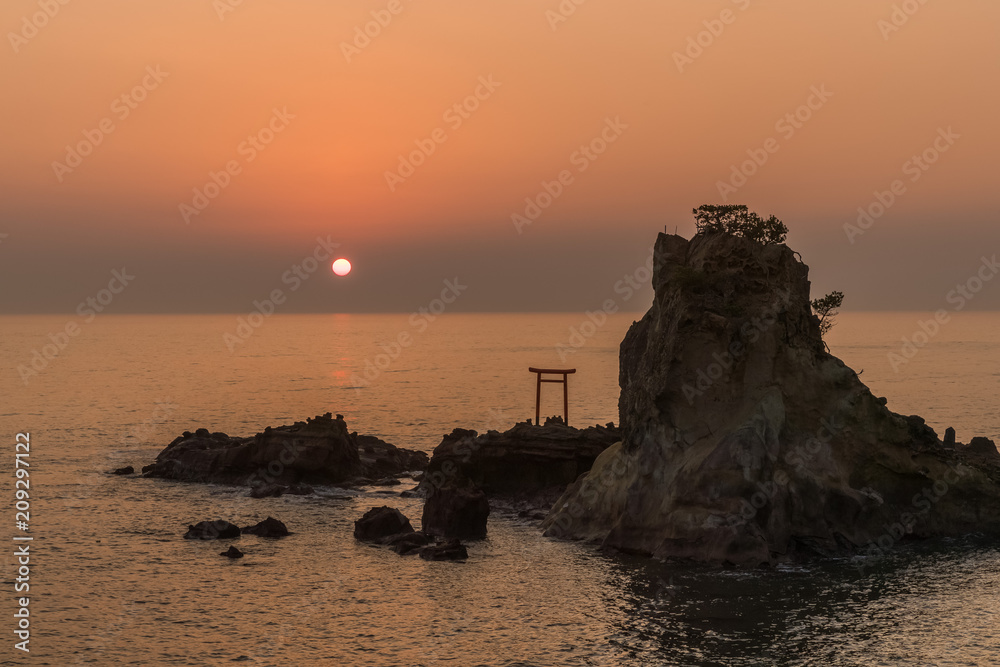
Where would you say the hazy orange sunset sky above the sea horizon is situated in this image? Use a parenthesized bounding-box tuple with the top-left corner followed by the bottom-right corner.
(0, 0, 1000, 313)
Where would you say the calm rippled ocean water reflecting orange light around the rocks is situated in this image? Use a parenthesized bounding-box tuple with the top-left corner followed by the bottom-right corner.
(0, 313, 1000, 667)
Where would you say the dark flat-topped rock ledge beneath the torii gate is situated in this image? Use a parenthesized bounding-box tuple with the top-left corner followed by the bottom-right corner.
(419, 419, 621, 497)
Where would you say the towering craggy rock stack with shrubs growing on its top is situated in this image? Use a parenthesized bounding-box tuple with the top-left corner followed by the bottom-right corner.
(545, 234, 1000, 565)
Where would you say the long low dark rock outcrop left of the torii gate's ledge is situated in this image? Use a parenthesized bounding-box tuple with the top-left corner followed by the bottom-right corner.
(142, 413, 427, 486)
